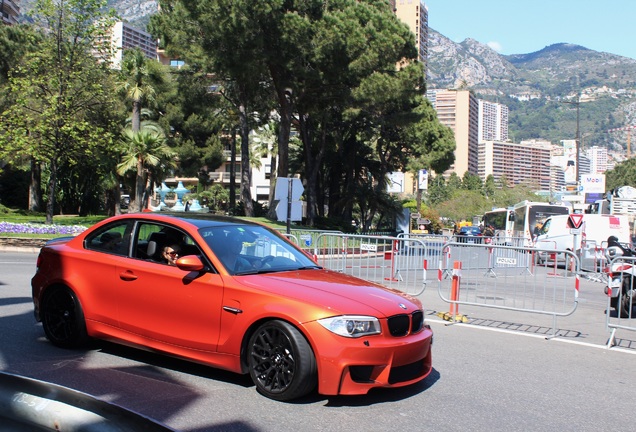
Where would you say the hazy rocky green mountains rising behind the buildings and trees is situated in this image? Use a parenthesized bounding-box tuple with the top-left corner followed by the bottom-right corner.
(20, 0, 636, 151)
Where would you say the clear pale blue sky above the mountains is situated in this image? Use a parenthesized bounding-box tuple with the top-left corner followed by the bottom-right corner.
(424, 0, 636, 59)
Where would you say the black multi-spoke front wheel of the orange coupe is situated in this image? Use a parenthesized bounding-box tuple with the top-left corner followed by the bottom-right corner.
(247, 321, 318, 401)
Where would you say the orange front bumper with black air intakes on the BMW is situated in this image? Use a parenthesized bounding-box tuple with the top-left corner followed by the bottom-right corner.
(308, 323, 433, 395)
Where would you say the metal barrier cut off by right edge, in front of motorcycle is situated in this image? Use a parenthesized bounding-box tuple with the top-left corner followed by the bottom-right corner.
(605, 256, 636, 348)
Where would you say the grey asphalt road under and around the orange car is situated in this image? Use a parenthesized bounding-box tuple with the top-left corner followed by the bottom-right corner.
(0, 252, 636, 432)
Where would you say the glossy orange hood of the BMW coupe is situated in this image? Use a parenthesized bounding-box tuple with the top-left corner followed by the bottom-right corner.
(235, 269, 422, 317)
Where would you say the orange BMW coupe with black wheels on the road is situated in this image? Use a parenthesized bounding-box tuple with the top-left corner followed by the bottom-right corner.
(31, 213, 432, 400)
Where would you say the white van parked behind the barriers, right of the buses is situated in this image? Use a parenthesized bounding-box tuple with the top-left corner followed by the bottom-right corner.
(534, 214, 631, 262)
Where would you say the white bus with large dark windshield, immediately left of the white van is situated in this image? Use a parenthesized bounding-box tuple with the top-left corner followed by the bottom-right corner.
(512, 201, 572, 247)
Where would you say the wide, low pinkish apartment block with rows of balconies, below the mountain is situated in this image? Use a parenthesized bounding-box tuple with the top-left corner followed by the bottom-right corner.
(479, 141, 552, 191)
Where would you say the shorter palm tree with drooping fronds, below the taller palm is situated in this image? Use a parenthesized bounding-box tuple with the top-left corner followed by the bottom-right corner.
(117, 122, 176, 211)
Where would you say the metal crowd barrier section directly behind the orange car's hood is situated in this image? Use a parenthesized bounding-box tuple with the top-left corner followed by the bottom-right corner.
(313, 233, 428, 296)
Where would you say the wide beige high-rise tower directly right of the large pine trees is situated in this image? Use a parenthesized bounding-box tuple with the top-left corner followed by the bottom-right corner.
(426, 90, 479, 177)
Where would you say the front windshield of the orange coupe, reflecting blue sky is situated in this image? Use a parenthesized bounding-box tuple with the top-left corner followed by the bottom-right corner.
(199, 225, 320, 275)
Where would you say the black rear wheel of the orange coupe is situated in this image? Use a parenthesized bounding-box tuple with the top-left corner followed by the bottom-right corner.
(41, 286, 88, 348)
